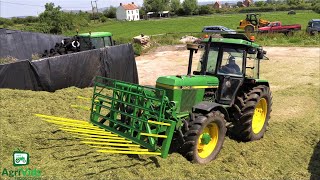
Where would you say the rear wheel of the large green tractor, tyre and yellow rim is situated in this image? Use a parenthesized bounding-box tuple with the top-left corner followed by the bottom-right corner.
(232, 85, 272, 141)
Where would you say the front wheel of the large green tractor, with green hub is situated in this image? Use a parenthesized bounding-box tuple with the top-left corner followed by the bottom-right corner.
(182, 111, 227, 164)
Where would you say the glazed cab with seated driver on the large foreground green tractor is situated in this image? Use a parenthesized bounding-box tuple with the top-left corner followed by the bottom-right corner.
(193, 34, 265, 105)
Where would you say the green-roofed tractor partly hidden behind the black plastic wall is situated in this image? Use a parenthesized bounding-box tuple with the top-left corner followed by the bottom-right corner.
(42, 32, 114, 57)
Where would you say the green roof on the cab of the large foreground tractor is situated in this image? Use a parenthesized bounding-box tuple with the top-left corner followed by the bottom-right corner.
(202, 34, 260, 48)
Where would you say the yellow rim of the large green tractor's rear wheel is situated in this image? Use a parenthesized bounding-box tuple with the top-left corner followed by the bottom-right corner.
(252, 98, 268, 134)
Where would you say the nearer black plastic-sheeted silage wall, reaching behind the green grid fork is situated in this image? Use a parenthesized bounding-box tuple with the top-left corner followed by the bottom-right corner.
(0, 44, 139, 92)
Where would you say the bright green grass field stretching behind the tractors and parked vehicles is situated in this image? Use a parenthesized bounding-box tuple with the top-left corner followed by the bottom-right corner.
(66, 11, 320, 46)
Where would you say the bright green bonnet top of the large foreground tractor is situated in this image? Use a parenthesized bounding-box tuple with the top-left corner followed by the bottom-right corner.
(157, 75, 219, 86)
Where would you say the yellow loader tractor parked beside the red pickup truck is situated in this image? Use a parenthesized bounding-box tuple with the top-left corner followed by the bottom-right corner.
(237, 13, 270, 33)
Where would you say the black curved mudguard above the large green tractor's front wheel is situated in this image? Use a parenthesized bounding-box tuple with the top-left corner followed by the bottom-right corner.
(192, 101, 229, 121)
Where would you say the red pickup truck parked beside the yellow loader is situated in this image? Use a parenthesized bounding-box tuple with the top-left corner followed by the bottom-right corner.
(258, 21, 301, 35)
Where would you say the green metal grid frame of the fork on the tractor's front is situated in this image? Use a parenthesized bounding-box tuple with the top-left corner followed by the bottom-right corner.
(90, 76, 177, 158)
